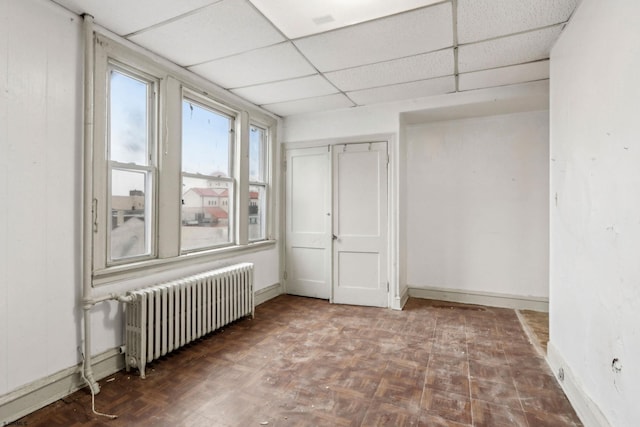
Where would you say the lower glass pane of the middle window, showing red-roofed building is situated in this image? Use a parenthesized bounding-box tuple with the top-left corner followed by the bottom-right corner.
(181, 177, 233, 250)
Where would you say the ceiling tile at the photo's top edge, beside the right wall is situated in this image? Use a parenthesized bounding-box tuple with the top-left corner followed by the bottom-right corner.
(458, 0, 579, 44)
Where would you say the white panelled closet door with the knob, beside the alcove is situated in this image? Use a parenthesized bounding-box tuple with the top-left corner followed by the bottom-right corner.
(332, 142, 389, 307)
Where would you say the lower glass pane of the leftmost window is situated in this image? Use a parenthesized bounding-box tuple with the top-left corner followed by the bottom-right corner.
(110, 169, 151, 260)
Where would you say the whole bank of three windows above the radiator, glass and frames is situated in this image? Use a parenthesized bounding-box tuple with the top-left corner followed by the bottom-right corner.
(89, 34, 276, 284)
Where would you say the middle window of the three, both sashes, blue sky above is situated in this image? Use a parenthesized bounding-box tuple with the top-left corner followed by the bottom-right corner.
(180, 98, 235, 251)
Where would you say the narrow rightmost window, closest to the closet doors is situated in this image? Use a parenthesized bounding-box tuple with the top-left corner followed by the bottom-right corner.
(249, 125, 267, 241)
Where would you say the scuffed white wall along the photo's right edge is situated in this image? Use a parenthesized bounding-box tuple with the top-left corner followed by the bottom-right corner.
(549, 0, 640, 426)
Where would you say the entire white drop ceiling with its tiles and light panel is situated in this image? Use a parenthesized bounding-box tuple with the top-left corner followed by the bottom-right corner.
(53, 0, 580, 116)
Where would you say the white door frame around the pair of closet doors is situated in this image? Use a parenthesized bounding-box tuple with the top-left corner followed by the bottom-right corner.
(280, 133, 400, 310)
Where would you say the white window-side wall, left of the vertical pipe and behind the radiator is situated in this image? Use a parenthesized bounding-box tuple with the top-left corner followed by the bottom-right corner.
(0, 0, 279, 408)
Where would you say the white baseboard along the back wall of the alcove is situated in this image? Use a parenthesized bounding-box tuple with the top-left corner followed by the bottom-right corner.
(409, 287, 549, 313)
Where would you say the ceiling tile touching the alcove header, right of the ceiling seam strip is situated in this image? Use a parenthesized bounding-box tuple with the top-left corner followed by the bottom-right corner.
(458, 61, 549, 90)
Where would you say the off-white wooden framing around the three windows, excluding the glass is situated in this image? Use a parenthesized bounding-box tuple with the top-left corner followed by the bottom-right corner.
(90, 32, 278, 286)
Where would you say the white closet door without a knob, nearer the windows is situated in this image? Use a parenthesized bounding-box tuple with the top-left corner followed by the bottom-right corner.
(285, 146, 331, 299)
